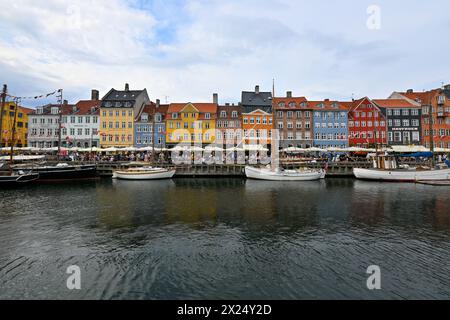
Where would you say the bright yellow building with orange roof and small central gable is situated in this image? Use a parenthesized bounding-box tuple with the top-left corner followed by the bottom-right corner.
(166, 102, 218, 146)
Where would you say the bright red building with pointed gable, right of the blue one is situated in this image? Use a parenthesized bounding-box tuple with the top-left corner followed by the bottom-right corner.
(347, 97, 387, 148)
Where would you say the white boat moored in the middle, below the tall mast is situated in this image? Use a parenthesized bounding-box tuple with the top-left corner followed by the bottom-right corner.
(245, 166, 325, 181)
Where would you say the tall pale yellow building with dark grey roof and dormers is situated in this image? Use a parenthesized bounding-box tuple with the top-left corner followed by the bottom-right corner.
(98, 84, 150, 148)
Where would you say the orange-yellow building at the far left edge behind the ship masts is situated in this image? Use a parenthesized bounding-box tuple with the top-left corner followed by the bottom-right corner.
(0, 102, 33, 147)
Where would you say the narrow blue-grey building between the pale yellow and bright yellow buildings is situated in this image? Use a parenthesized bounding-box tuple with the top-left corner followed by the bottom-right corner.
(134, 100, 168, 148)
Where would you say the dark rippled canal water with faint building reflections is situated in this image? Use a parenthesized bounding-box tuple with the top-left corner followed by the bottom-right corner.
(0, 179, 450, 299)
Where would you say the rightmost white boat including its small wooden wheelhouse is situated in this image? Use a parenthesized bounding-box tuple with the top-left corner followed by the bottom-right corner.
(353, 156, 450, 182)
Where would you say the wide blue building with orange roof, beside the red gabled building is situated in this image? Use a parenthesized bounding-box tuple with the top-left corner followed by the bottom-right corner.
(308, 100, 348, 148)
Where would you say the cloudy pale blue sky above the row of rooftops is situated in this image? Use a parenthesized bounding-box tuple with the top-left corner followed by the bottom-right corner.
(0, 0, 450, 107)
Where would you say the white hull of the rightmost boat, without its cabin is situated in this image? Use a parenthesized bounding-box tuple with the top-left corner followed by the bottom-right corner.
(353, 168, 450, 182)
